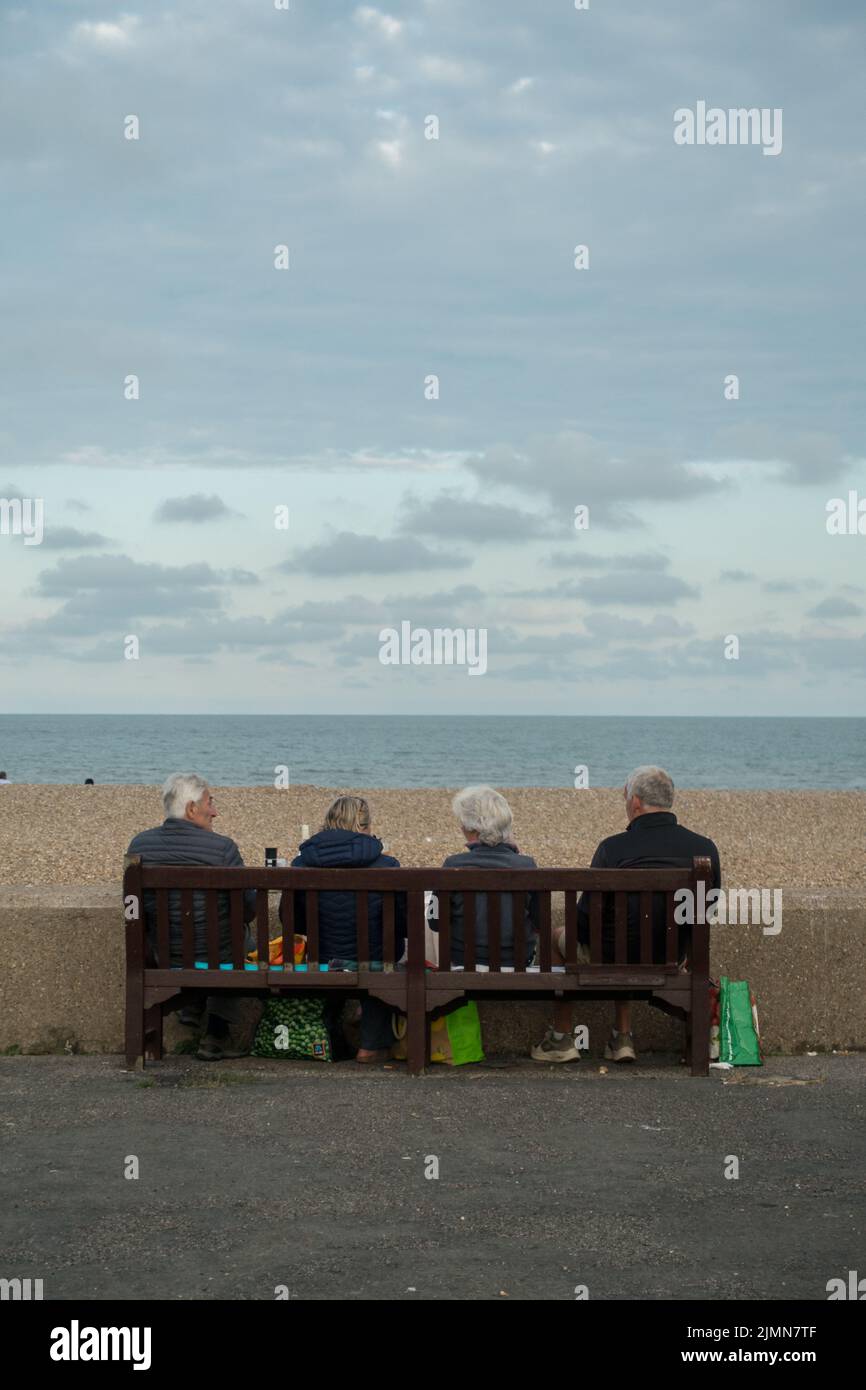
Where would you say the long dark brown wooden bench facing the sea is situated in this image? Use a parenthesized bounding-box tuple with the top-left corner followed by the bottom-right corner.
(124, 858, 712, 1076)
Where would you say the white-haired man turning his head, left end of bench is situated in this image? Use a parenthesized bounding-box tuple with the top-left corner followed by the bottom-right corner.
(126, 773, 256, 1062)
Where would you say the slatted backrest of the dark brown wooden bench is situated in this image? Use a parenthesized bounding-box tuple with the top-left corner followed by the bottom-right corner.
(124, 858, 712, 973)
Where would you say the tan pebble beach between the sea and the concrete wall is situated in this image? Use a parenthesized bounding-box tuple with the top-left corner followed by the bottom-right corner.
(0, 784, 866, 888)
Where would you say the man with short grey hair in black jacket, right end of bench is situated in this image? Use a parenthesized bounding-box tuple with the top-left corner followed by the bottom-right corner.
(530, 767, 721, 1062)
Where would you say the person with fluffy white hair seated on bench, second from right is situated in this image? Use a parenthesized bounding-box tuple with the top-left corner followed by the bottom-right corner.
(428, 787, 538, 969)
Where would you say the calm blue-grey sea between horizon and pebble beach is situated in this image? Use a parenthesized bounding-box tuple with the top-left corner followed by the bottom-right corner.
(0, 714, 866, 795)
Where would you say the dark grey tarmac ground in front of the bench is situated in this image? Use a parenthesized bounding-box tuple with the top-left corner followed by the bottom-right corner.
(0, 1054, 866, 1300)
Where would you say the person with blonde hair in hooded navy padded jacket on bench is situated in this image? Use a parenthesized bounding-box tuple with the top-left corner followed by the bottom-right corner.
(279, 796, 406, 1062)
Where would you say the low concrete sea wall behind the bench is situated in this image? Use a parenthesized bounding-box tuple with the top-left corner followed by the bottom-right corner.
(0, 884, 866, 1055)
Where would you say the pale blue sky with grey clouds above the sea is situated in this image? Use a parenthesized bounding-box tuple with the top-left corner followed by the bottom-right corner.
(0, 0, 866, 714)
